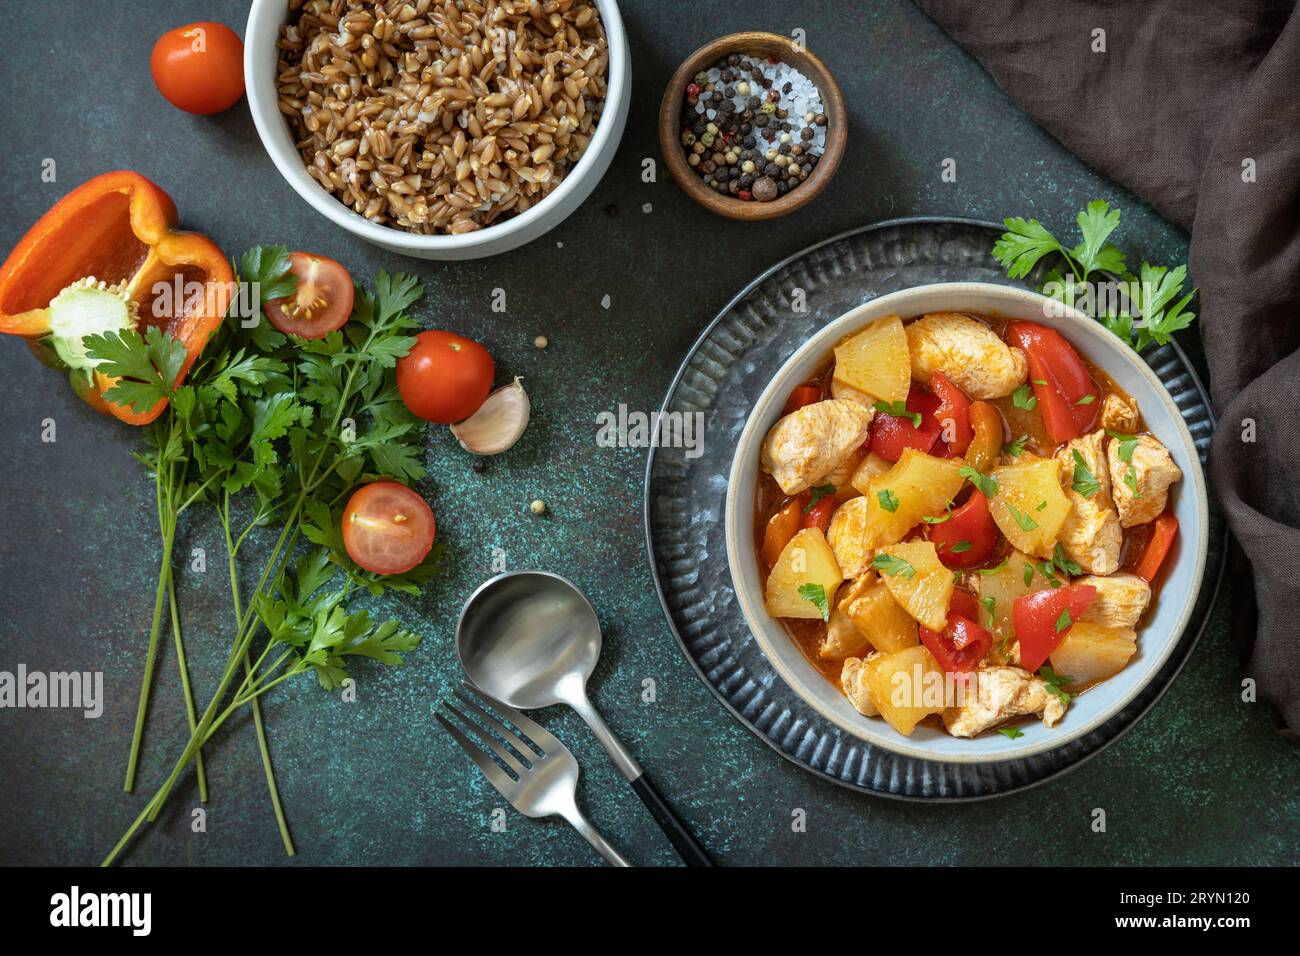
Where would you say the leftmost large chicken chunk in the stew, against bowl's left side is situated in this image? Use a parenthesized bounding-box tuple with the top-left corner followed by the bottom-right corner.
(763, 398, 875, 494)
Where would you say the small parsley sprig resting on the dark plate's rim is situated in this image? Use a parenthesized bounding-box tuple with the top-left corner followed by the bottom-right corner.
(993, 199, 1196, 351)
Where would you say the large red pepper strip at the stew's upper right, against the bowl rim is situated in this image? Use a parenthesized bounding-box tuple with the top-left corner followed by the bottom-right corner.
(1006, 323, 1101, 441)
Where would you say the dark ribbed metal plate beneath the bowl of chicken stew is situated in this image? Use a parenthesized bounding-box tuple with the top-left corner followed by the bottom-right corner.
(645, 219, 1226, 800)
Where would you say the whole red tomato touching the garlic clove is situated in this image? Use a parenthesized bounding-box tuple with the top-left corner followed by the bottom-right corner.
(398, 329, 497, 425)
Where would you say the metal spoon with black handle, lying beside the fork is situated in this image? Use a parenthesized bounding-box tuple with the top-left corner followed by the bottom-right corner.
(456, 571, 714, 866)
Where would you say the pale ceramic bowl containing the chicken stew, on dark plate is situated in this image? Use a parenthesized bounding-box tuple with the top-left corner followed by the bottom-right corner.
(727, 282, 1209, 763)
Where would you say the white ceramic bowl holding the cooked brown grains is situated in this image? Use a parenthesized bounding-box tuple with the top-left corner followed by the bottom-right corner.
(244, 0, 632, 259)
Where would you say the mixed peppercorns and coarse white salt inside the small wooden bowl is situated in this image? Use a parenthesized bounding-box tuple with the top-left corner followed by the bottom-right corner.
(681, 53, 827, 203)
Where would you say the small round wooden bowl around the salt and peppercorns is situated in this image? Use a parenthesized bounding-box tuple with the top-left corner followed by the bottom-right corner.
(659, 33, 849, 221)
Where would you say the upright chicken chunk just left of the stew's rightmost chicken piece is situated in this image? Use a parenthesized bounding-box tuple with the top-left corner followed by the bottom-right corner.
(1057, 432, 1123, 575)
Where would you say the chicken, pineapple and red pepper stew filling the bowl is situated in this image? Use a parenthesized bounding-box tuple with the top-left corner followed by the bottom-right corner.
(755, 312, 1182, 737)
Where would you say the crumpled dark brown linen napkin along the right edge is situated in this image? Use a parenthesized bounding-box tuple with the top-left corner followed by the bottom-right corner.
(917, 0, 1300, 731)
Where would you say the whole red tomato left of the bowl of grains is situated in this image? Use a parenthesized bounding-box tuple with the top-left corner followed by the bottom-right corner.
(150, 22, 243, 116)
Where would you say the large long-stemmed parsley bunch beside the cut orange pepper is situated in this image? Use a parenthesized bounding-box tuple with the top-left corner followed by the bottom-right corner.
(87, 246, 442, 864)
